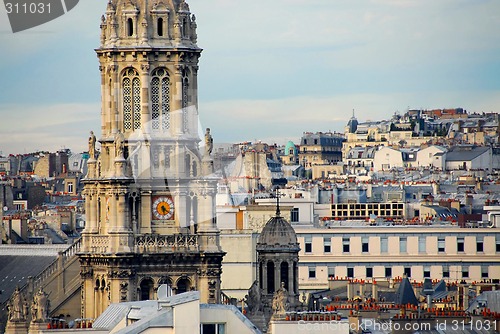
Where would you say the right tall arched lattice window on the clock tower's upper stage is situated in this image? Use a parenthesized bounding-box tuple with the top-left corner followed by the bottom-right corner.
(151, 68, 170, 130)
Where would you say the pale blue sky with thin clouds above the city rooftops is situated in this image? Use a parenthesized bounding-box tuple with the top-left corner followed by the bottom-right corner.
(0, 0, 500, 155)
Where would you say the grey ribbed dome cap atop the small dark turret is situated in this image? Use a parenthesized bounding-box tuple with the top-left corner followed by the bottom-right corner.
(257, 215, 299, 249)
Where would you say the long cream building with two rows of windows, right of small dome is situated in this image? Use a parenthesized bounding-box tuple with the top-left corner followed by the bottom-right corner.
(296, 224, 500, 290)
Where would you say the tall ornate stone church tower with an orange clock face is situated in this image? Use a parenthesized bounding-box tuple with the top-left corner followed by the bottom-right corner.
(79, 0, 224, 318)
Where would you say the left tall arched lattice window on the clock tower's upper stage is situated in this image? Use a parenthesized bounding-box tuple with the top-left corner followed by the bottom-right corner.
(123, 68, 141, 131)
